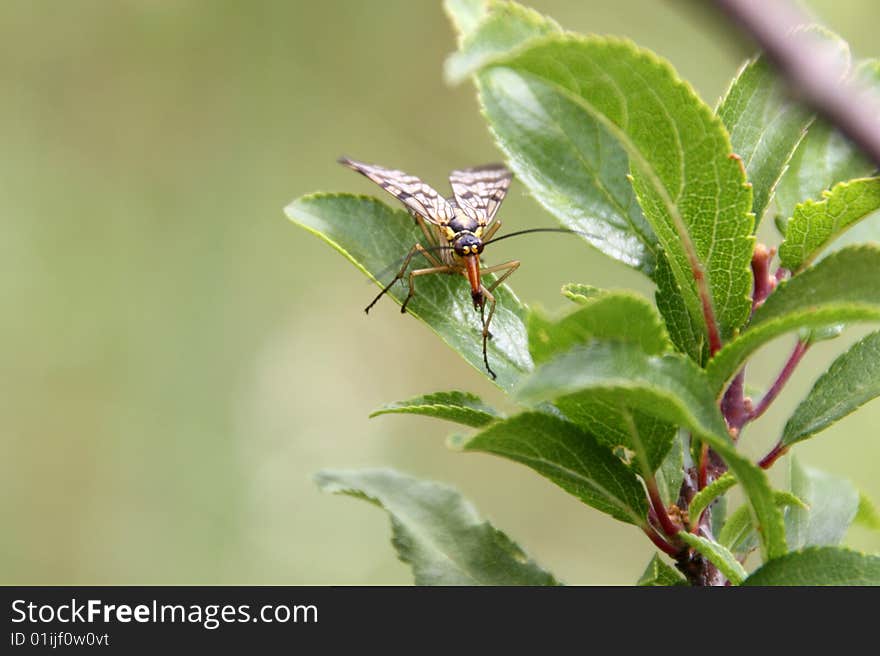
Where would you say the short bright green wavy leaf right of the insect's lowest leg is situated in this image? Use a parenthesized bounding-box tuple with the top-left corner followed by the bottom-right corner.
(528, 292, 671, 363)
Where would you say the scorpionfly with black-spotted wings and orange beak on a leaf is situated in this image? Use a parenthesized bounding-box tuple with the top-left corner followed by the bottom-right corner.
(339, 157, 520, 380)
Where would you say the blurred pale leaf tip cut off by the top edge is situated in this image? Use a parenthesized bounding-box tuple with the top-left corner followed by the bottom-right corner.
(445, 2, 562, 84)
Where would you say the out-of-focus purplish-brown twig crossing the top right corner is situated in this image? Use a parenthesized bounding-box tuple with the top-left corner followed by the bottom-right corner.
(717, 0, 880, 165)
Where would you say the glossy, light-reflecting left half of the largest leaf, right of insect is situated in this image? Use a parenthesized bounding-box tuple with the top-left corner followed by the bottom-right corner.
(479, 48, 657, 273)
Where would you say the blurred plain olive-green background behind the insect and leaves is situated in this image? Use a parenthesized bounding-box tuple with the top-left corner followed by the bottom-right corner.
(0, 0, 880, 584)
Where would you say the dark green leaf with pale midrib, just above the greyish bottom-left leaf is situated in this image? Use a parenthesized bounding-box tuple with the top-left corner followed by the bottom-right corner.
(453, 412, 648, 526)
